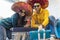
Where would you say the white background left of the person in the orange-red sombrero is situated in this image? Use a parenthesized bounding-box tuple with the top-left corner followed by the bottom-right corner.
(0, 0, 14, 18)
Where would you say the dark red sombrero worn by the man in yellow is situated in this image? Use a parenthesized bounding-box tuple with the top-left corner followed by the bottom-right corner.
(27, 0, 49, 9)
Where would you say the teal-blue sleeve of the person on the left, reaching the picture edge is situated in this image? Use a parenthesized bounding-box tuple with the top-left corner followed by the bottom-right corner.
(0, 14, 16, 29)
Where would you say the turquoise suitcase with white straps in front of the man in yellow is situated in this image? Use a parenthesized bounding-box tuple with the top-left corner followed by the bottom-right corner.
(29, 30, 51, 40)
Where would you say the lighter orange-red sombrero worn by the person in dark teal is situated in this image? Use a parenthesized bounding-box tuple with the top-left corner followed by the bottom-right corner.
(12, 2, 32, 16)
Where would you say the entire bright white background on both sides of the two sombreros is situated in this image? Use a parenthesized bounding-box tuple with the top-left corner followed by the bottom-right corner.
(0, 0, 60, 18)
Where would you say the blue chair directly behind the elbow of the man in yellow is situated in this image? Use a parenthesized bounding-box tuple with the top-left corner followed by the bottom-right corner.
(46, 16, 56, 34)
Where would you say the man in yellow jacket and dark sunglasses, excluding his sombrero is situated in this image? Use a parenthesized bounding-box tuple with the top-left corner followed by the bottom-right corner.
(31, 3, 49, 29)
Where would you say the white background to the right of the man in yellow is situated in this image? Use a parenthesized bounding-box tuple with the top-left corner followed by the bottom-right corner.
(48, 0, 60, 18)
